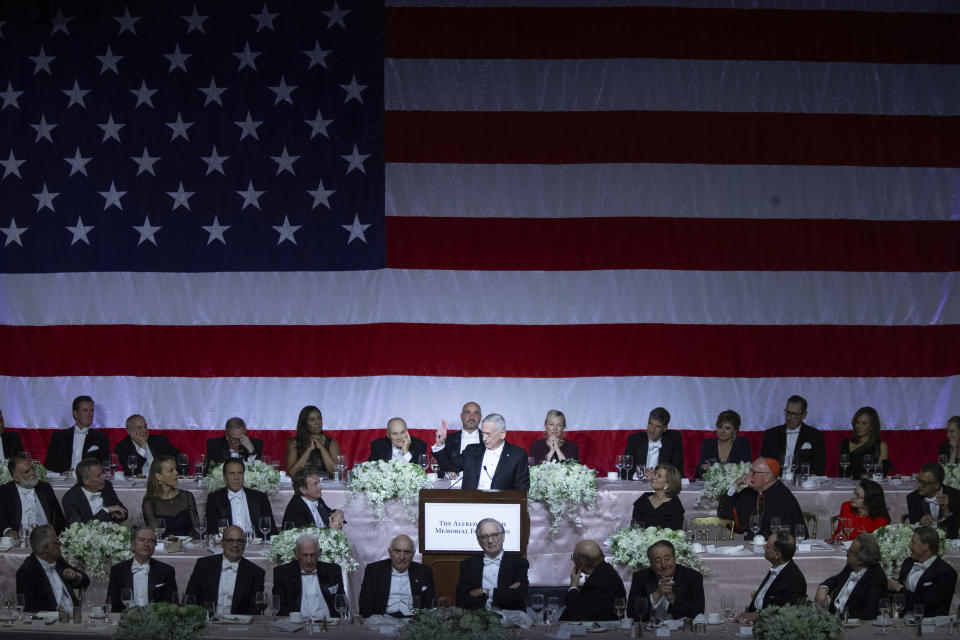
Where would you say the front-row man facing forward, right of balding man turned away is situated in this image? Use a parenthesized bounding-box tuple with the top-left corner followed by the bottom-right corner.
(627, 540, 704, 620)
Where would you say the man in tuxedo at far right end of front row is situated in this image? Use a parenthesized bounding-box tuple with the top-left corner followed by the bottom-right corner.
(887, 526, 957, 617)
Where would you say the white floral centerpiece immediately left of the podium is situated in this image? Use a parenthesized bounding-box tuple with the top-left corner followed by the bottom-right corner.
(347, 460, 431, 521)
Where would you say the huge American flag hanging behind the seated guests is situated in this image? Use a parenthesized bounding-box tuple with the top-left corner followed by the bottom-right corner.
(0, 0, 960, 476)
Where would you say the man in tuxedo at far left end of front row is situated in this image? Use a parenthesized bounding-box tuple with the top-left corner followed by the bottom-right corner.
(17, 524, 90, 613)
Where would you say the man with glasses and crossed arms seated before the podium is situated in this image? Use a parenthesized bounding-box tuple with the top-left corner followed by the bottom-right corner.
(456, 518, 530, 610)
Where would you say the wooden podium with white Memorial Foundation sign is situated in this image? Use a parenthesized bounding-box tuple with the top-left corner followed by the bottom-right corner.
(418, 489, 530, 605)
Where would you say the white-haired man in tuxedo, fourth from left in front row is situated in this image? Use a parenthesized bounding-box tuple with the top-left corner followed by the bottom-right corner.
(273, 533, 344, 618)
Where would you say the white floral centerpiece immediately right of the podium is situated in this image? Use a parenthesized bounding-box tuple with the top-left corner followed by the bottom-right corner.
(527, 462, 597, 535)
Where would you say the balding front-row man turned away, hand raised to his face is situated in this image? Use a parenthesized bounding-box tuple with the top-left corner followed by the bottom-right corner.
(560, 540, 627, 620)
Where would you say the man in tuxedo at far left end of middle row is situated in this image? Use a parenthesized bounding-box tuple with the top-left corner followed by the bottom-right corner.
(0, 455, 66, 540)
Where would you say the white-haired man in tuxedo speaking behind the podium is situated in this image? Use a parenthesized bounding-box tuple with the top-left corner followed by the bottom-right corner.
(461, 413, 530, 491)
